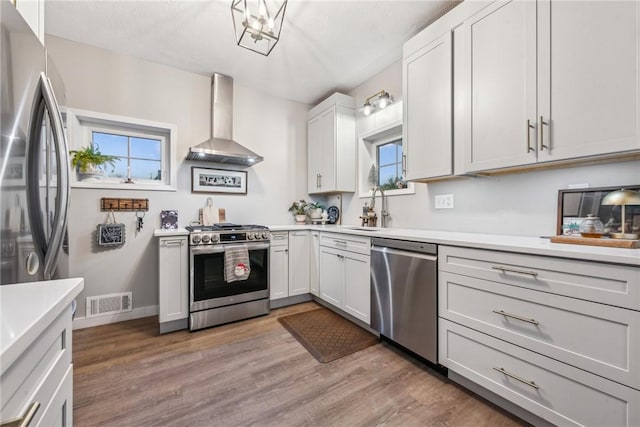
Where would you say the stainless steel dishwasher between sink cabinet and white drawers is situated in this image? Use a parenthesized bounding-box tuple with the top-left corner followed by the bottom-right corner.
(371, 238, 438, 364)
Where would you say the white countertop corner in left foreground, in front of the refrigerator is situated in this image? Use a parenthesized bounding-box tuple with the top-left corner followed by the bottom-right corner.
(0, 278, 84, 373)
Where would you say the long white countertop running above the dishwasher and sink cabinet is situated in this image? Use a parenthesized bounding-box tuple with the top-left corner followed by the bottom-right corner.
(269, 224, 640, 268)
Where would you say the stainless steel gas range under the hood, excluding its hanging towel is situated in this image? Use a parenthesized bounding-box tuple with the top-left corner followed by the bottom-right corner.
(187, 223, 270, 331)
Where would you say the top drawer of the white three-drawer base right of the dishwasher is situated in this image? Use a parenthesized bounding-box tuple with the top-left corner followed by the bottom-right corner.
(438, 246, 640, 310)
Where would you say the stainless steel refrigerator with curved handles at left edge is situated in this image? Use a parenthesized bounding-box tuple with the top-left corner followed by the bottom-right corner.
(0, 0, 69, 284)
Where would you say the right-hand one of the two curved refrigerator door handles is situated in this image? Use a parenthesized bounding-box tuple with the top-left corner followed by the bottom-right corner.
(40, 73, 70, 279)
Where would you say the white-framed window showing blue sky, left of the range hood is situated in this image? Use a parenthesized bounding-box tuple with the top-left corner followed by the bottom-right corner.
(68, 110, 176, 191)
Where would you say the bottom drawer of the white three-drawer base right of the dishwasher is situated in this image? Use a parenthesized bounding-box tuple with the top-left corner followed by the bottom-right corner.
(439, 319, 640, 426)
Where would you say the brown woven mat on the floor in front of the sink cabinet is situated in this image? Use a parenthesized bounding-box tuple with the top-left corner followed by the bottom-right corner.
(278, 308, 378, 363)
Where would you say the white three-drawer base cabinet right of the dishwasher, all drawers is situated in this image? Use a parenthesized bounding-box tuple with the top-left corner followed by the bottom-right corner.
(438, 246, 640, 426)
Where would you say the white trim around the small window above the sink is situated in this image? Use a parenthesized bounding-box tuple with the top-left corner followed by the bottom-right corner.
(358, 110, 416, 199)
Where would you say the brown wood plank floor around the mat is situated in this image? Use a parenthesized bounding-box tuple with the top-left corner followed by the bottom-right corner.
(73, 302, 526, 427)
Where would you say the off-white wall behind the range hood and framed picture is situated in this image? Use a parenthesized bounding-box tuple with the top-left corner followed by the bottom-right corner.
(47, 37, 309, 316)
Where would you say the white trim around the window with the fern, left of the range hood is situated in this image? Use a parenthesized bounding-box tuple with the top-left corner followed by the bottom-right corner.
(67, 108, 178, 191)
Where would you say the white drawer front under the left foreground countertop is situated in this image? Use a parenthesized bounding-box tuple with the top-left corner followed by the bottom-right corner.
(1, 306, 71, 425)
